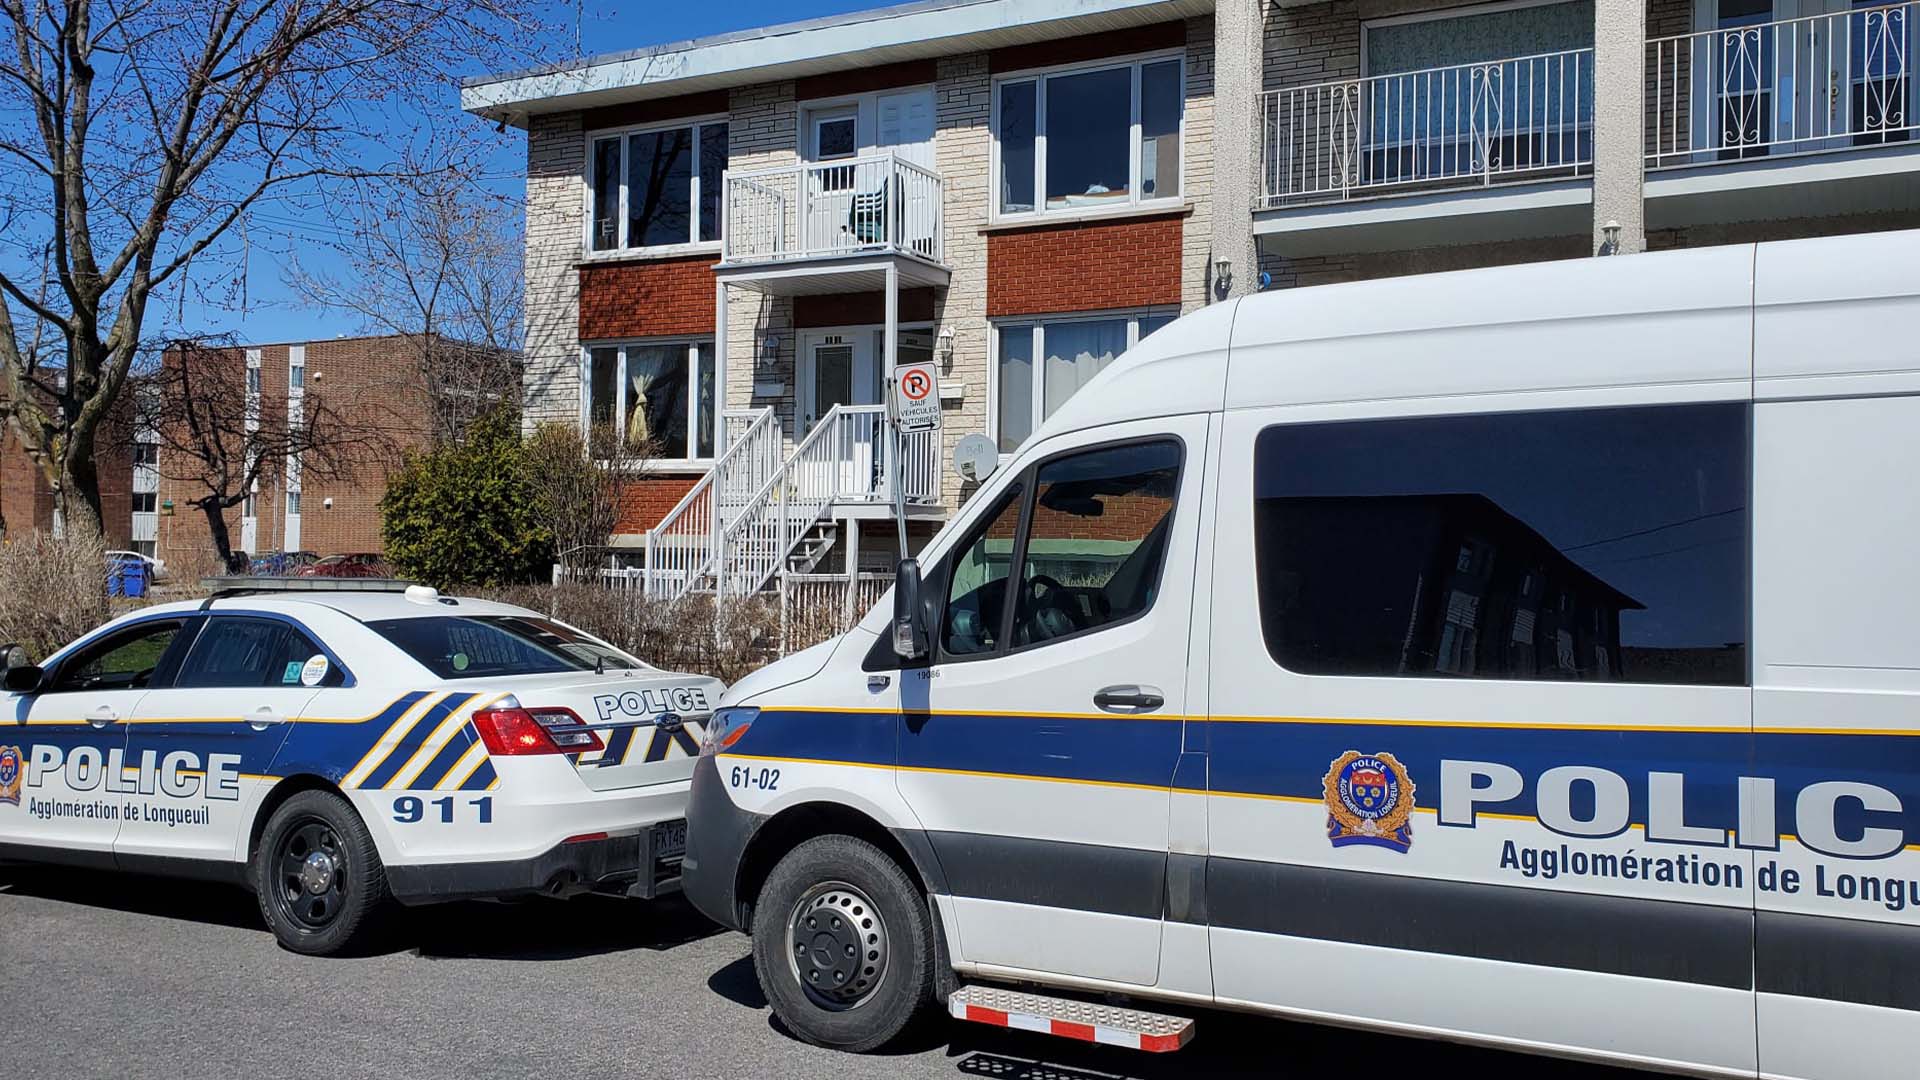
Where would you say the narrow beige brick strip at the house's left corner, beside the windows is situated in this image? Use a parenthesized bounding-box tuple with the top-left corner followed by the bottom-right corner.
(522, 113, 586, 429)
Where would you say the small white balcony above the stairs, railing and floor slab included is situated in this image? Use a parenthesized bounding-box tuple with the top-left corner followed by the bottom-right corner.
(716, 154, 948, 294)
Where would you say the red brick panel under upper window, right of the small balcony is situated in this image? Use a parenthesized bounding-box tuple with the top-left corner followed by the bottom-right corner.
(987, 213, 1185, 317)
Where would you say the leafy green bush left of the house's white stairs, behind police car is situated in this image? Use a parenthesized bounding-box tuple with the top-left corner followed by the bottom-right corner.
(380, 411, 553, 588)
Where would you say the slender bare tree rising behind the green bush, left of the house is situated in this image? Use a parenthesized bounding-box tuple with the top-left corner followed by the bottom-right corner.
(286, 144, 526, 444)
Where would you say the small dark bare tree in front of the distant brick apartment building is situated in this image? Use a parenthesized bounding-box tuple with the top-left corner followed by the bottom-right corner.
(149, 342, 397, 565)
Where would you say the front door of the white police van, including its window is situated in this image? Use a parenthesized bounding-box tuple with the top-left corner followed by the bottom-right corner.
(899, 417, 1208, 986)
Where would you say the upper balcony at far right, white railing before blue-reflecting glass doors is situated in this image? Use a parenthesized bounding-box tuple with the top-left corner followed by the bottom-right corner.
(1645, 0, 1920, 229)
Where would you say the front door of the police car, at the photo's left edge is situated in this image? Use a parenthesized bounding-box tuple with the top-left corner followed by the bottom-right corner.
(0, 619, 188, 865)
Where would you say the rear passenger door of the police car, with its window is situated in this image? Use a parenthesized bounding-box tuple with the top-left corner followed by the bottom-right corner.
(113, 615, 326, 861)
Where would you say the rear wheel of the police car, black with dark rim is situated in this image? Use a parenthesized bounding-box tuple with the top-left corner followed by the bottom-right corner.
(253, 792, 388, 957)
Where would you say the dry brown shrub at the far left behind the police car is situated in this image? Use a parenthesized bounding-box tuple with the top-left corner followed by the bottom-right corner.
(0, 532, 113, 663)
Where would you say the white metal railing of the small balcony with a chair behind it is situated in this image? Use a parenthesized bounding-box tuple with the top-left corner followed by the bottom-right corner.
(720, 154, 945, 263)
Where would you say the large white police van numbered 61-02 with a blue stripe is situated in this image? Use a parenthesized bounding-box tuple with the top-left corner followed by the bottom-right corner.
(684, 233, 1920, 1080)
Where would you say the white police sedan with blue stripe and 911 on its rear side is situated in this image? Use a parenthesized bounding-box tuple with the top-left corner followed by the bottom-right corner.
(0, 578, 722, 955)
